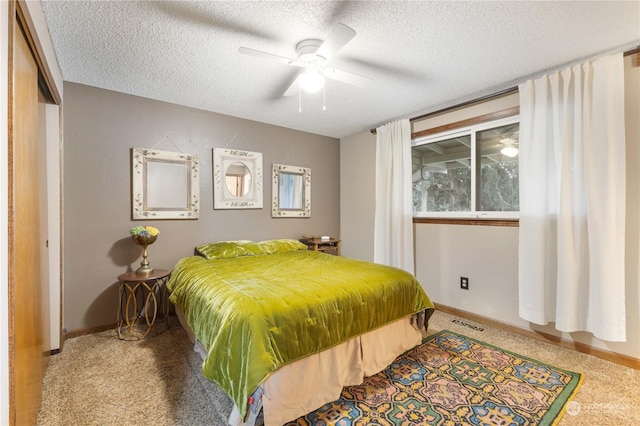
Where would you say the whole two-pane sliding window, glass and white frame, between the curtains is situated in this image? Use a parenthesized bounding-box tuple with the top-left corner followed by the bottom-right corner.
(411, 117, 519, 218)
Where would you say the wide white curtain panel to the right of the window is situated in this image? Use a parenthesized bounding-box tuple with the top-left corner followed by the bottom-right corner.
(519, 54, 626, 341)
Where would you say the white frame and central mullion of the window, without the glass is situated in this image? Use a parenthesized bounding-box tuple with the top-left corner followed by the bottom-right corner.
(411, 114, 520, 220)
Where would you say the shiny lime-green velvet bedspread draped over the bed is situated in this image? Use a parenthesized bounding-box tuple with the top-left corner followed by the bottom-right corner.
(167, 251, 433, 415)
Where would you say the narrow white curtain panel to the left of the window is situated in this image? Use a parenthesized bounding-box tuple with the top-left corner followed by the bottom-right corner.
(373, 119, 414, 274)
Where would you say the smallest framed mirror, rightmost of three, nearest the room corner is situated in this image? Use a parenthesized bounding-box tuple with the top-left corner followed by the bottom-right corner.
(271, 164, 311, 217)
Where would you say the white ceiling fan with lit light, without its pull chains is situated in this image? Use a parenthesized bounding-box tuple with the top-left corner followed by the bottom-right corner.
(238, 24, 372, 96)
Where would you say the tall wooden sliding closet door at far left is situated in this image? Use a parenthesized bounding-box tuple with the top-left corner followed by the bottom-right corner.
(8, 8, 50, 426)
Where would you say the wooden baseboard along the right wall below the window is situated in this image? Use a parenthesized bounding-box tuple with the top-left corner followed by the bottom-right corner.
(434, 303, 640, 370)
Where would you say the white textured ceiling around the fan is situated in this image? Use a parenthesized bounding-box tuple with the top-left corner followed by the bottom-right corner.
(42, 0, 640, 138)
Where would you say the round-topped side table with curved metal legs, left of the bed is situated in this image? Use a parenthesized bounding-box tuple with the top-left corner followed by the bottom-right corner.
(117, 269, 171, 340)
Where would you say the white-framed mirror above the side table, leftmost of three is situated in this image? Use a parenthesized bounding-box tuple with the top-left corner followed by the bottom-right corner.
(131, 148, 200, 220)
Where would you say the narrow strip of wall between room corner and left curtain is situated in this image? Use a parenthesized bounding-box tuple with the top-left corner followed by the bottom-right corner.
(340, 132, 376, 261)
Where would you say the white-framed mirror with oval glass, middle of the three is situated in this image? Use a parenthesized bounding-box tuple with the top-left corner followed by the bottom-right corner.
(213, 148, 262, 209)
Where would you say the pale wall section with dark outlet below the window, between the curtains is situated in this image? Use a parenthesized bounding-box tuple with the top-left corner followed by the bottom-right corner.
(414, 224, 526, 326)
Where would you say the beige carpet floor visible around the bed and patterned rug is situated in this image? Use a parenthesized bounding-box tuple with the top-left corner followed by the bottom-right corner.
(38, 312, 640, 426)
